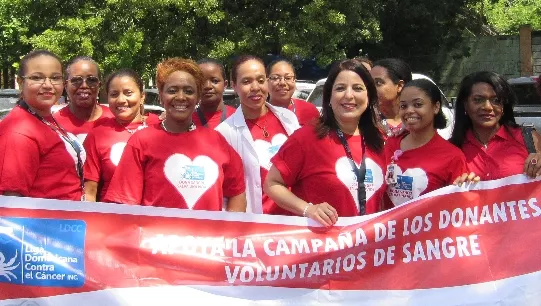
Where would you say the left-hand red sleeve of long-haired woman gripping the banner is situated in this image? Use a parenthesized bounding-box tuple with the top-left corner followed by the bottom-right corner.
(271, 137, 305, 186)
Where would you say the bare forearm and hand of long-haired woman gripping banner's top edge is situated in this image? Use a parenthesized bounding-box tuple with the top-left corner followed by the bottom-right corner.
(263, 166, 338, 226)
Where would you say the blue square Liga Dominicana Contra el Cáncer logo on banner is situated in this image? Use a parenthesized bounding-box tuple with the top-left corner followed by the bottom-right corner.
(0, 218, 86, 287)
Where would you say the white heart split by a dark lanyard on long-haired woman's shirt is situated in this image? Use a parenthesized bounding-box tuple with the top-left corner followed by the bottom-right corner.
(334, 156, 383, 207)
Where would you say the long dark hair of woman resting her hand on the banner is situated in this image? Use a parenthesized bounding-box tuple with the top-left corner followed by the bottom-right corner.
(316, 60, 383, 152)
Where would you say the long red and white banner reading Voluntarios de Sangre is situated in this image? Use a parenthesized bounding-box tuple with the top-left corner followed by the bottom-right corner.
(0, 176, 541, 306)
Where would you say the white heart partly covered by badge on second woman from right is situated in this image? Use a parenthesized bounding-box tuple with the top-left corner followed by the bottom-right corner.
(387, 165, 428, 206)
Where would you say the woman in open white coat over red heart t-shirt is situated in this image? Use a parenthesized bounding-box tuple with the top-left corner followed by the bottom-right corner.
(216, 56, 299, 214)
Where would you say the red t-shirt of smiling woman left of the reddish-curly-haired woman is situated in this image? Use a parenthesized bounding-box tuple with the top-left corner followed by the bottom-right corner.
(84, 114, 160, 200)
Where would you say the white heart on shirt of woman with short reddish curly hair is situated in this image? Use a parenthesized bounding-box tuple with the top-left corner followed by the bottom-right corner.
(163, 154, 219, 209)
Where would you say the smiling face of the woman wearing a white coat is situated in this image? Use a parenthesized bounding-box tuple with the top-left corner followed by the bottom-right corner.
(233, 60, 269, 112)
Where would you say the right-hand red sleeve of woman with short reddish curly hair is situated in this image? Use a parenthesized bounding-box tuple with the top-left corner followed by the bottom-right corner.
(218, 134, 246, 198)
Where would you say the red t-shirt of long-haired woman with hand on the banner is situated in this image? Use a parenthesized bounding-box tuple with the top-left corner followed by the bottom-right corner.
(272, 125, 386, 217)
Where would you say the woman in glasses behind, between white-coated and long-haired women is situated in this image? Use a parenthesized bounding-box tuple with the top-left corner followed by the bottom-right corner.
(267, 59, 319, 126)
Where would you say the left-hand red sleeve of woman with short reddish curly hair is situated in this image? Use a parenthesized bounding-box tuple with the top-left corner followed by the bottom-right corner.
(104, 134, 145, 204)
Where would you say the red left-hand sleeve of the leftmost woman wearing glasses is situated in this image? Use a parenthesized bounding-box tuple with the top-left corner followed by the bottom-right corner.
(0, 133, 40, 196)
